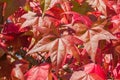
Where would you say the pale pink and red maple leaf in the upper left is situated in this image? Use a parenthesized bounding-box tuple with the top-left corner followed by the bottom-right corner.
(21, 11, 59, 34)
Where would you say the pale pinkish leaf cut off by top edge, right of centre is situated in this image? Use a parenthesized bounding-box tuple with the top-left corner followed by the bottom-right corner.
(86, 0, 107, 16)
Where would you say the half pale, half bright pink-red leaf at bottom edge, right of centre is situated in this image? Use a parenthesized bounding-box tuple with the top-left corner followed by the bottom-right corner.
(70, 63, 105, 80)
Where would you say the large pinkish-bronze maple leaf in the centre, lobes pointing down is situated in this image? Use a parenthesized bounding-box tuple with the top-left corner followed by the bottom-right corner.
(28, 35, 82, 67)
